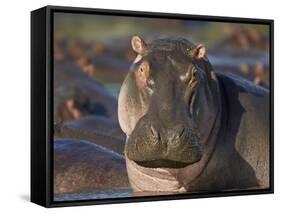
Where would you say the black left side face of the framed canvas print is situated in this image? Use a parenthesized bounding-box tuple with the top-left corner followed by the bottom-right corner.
(30, 7, 48, 206)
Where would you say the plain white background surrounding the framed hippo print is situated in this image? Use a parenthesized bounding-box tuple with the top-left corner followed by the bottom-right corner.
(0, 0, 281, 214)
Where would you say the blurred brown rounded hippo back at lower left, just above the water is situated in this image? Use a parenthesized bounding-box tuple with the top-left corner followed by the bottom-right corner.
(54, 139, 130, 194)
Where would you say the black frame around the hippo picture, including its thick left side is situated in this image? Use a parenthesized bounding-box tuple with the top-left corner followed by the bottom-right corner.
(31, 6, 274, 207)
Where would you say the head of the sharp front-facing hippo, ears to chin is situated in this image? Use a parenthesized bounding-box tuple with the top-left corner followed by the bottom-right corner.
(118, 36, 219, 168)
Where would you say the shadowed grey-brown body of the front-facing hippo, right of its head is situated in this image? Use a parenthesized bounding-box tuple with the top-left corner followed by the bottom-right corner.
(183, 74, 269, 191)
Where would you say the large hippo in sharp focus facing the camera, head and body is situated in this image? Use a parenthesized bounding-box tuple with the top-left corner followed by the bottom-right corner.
(118, 36, 270, 194)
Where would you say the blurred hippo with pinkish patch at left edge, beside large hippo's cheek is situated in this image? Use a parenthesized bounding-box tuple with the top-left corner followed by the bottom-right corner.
(54, 62, 117, 123)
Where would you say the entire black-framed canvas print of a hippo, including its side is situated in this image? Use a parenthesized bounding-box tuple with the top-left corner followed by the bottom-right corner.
(31, 6, 273, 207)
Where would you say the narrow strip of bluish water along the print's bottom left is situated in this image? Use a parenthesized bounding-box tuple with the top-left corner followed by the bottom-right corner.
(54, 189, 132, 201)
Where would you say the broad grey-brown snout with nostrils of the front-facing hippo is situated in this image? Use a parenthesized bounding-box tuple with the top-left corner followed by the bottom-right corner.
(125, 119, 202, 168)
